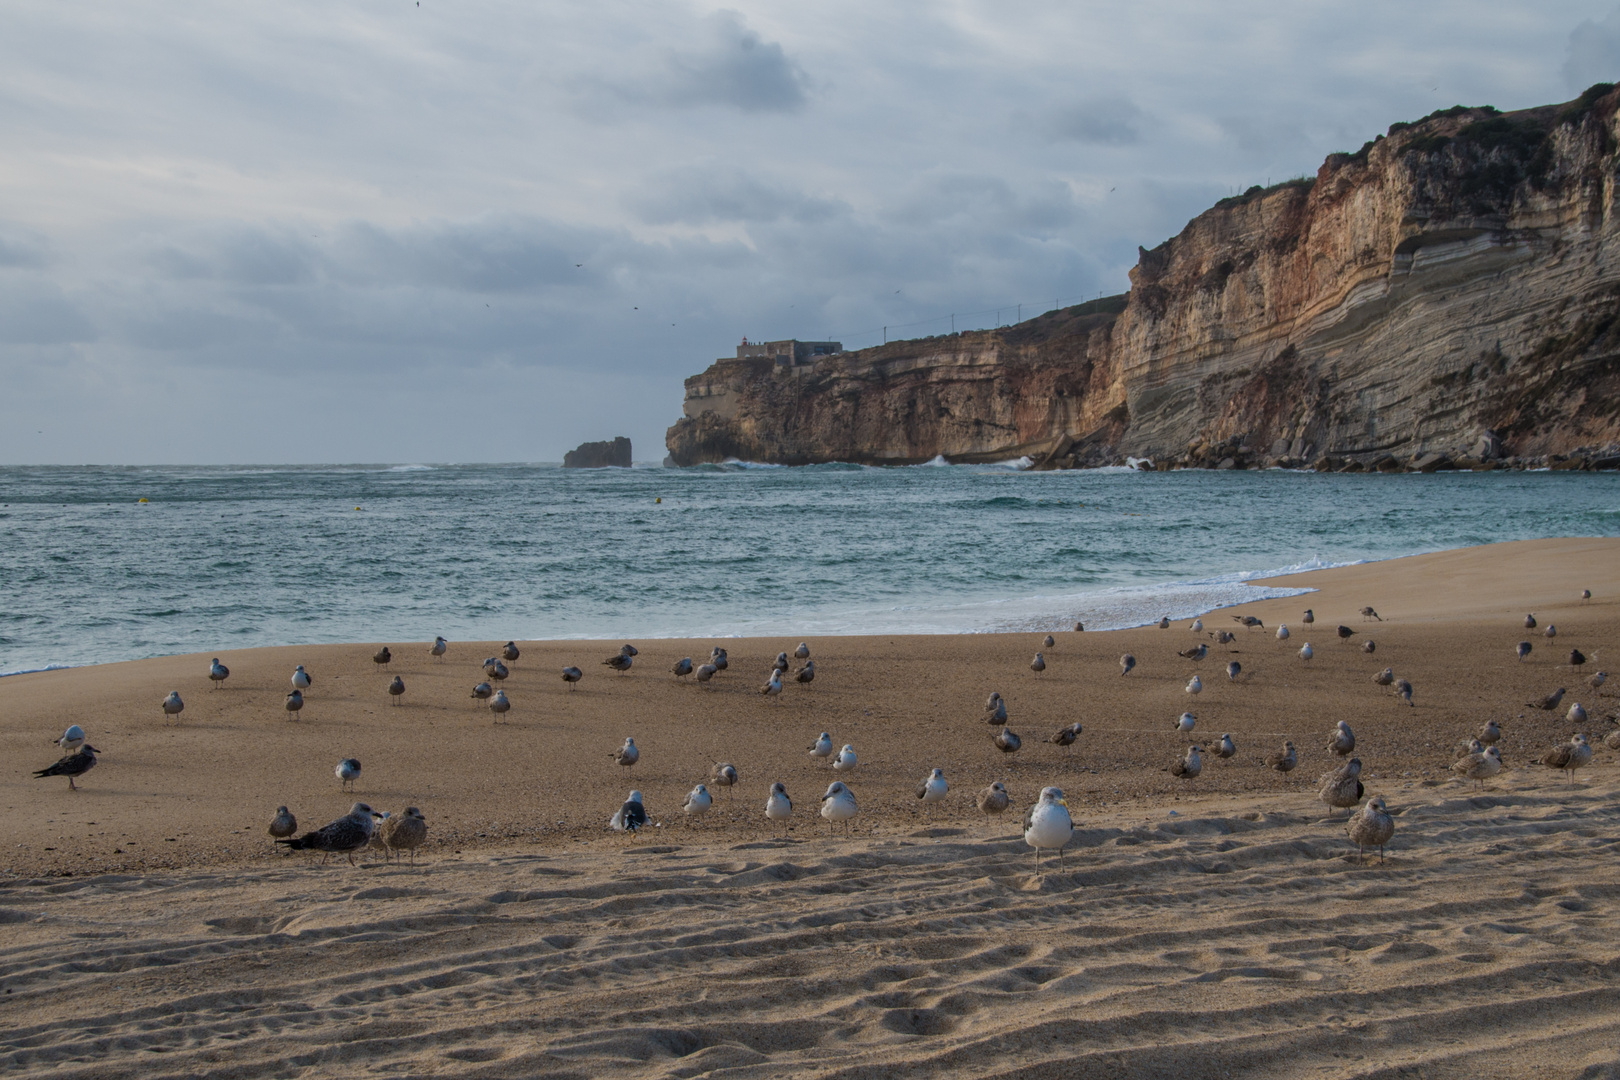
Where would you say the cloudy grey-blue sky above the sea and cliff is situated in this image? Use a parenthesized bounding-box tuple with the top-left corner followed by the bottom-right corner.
(0, 0, 1620, 465)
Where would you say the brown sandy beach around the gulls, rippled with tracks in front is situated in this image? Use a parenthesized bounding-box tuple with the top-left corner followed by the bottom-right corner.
(0, 539, 1620, 1077)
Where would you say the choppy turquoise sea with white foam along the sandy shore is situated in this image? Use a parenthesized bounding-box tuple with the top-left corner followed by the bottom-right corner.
(0, 465, 1620, 672)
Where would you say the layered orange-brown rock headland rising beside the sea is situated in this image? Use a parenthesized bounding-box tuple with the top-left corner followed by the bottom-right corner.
(667, 87, 1620, 466)
